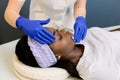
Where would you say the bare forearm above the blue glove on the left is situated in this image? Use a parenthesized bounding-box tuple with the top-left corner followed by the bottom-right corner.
(4, 0, 25, 27)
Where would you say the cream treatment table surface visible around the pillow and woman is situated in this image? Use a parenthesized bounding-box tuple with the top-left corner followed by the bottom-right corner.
(0, 25, 120, 80)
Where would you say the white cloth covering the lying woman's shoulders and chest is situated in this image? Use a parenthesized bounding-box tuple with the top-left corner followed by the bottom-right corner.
(76, 27, 120, 80)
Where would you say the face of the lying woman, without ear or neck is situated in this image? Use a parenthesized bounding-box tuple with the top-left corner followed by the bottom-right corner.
(49, 29, 75, 57)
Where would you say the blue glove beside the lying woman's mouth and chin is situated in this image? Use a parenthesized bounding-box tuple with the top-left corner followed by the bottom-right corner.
(74, 16, 87, 43)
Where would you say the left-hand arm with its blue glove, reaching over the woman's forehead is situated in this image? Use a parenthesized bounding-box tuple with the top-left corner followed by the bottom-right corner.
(4, 0, 55, 44)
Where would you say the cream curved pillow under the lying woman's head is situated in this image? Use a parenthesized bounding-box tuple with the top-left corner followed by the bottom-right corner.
(13, 54, 70, 80)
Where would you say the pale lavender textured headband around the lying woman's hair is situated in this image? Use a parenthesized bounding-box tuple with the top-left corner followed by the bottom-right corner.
(28, 37, 57, 68)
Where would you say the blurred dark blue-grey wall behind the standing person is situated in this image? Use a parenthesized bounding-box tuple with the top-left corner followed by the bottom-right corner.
(0, 0, 120, 45)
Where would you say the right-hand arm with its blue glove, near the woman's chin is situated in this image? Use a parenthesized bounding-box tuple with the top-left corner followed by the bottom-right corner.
(74, 0, 87, 43)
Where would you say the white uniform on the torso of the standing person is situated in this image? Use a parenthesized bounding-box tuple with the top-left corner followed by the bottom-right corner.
(30, 0, 76, 29)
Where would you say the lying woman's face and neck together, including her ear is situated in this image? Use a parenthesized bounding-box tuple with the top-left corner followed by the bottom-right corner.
(48, 28, 84, 65)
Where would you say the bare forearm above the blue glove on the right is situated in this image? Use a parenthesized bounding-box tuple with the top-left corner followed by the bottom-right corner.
(74, 0, 87, 19)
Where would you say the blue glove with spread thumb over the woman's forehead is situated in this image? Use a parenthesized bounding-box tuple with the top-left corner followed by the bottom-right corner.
(16, 16, 55, 44)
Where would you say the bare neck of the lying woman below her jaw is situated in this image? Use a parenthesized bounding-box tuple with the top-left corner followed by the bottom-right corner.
(70, 44, 84, 65)
